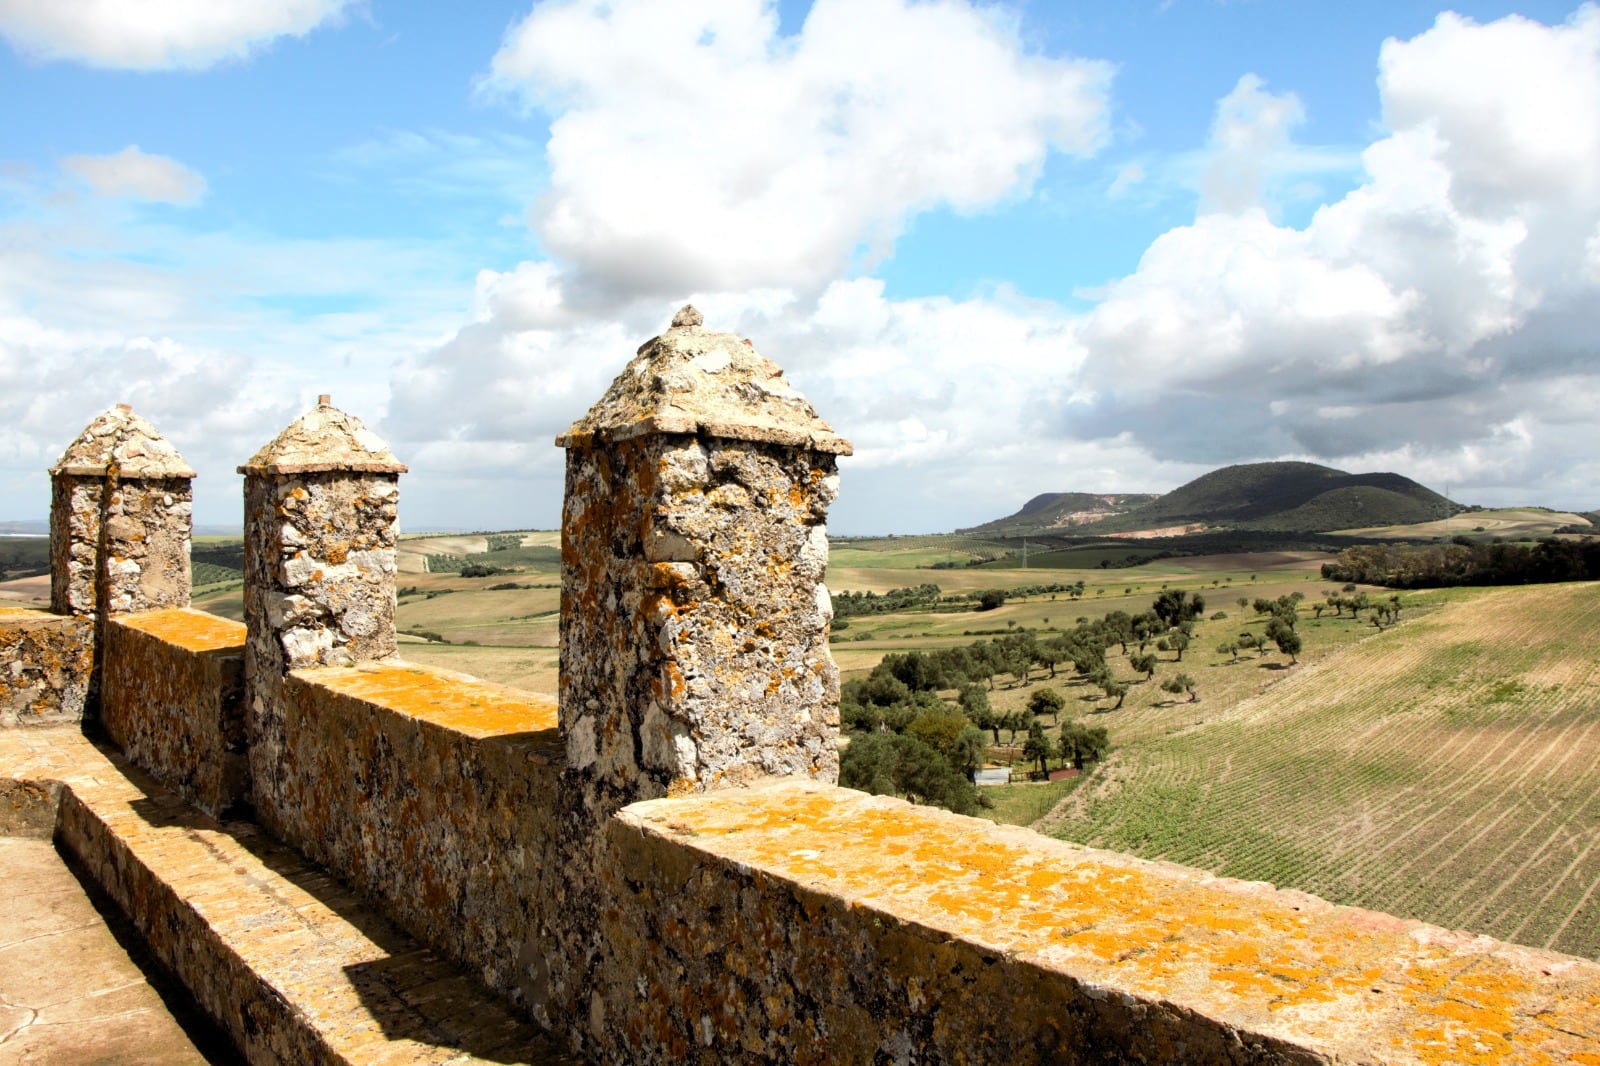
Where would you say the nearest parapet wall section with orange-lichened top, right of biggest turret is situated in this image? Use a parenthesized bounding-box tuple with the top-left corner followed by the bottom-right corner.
(595, 779, 1600, 1064)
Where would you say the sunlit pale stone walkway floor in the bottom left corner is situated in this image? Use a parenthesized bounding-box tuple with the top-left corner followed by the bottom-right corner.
(0, 837, 232, 1066)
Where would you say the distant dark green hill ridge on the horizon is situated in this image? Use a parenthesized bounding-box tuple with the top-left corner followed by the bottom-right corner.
(962, 463, 1459, 536)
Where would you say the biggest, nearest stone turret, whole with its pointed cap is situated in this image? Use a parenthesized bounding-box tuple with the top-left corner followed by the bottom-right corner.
(557, 307, 850, 813)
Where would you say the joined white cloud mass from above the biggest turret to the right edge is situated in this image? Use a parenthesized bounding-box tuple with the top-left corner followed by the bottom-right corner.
(390, 0, 1600, 528)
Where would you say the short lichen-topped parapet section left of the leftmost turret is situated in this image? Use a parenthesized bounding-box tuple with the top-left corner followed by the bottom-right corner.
(0, 607, 94, 728)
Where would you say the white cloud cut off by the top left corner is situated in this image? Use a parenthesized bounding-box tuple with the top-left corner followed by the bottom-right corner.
(0, 0, 352, 70)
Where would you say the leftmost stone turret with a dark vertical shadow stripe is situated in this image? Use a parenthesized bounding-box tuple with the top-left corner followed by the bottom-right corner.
(50, 403, 195, 616)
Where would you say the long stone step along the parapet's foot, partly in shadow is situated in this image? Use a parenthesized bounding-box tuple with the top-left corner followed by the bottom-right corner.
(0, 728, 579, 1066)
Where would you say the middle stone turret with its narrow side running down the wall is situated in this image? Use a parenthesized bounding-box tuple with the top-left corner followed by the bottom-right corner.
(238, 395, 406, 824)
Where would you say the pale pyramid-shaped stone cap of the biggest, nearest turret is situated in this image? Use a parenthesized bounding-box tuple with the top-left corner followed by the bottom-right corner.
(555, 307, 851, 455)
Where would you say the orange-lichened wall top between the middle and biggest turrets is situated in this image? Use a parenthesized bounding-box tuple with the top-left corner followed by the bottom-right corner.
(294, 663, 557, 738)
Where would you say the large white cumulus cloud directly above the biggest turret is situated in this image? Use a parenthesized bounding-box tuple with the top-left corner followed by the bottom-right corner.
(483, 0, 1110, 306)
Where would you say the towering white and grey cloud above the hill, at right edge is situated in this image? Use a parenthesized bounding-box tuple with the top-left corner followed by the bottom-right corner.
(1054, 5, 1600, 505)
